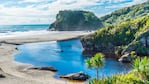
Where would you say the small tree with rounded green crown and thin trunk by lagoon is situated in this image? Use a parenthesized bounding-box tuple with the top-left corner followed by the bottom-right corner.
(85, 53, 105, 79)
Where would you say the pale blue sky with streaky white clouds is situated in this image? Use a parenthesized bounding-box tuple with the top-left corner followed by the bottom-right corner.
(0, 0, 147, 25)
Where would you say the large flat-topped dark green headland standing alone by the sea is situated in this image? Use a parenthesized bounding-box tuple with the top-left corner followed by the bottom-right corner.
(49, 10, 103, 31)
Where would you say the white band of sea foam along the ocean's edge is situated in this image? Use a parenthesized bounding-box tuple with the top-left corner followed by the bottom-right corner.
(0, 30, 58, 38)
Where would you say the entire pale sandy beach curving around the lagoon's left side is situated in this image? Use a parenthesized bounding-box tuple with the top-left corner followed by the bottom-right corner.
(0, 31, 89, 84)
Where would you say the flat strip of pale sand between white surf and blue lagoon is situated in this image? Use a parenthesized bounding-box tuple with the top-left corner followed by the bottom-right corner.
(0, 31, 93, 44)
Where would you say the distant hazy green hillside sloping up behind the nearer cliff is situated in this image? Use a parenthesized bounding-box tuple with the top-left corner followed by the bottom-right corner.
(100, 1, 149, 26)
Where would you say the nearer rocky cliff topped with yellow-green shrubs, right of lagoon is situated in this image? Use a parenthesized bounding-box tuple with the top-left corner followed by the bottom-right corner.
(81, 15, 149, 56)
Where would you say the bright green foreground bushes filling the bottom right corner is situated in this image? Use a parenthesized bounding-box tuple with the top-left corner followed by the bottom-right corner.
(88, 57, 149, 84)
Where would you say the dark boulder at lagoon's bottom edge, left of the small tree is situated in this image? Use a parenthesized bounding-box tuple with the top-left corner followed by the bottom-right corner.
(60, 72, 90, 81)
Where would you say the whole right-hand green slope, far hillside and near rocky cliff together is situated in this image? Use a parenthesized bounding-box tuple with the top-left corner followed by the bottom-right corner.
(81, 1, 149, 58)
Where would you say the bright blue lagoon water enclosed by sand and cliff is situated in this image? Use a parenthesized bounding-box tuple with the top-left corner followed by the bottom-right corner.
(14, 39, 131, 77)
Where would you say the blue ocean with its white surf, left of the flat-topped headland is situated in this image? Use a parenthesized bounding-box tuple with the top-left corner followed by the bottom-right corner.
(0, 24, 57, 38)
